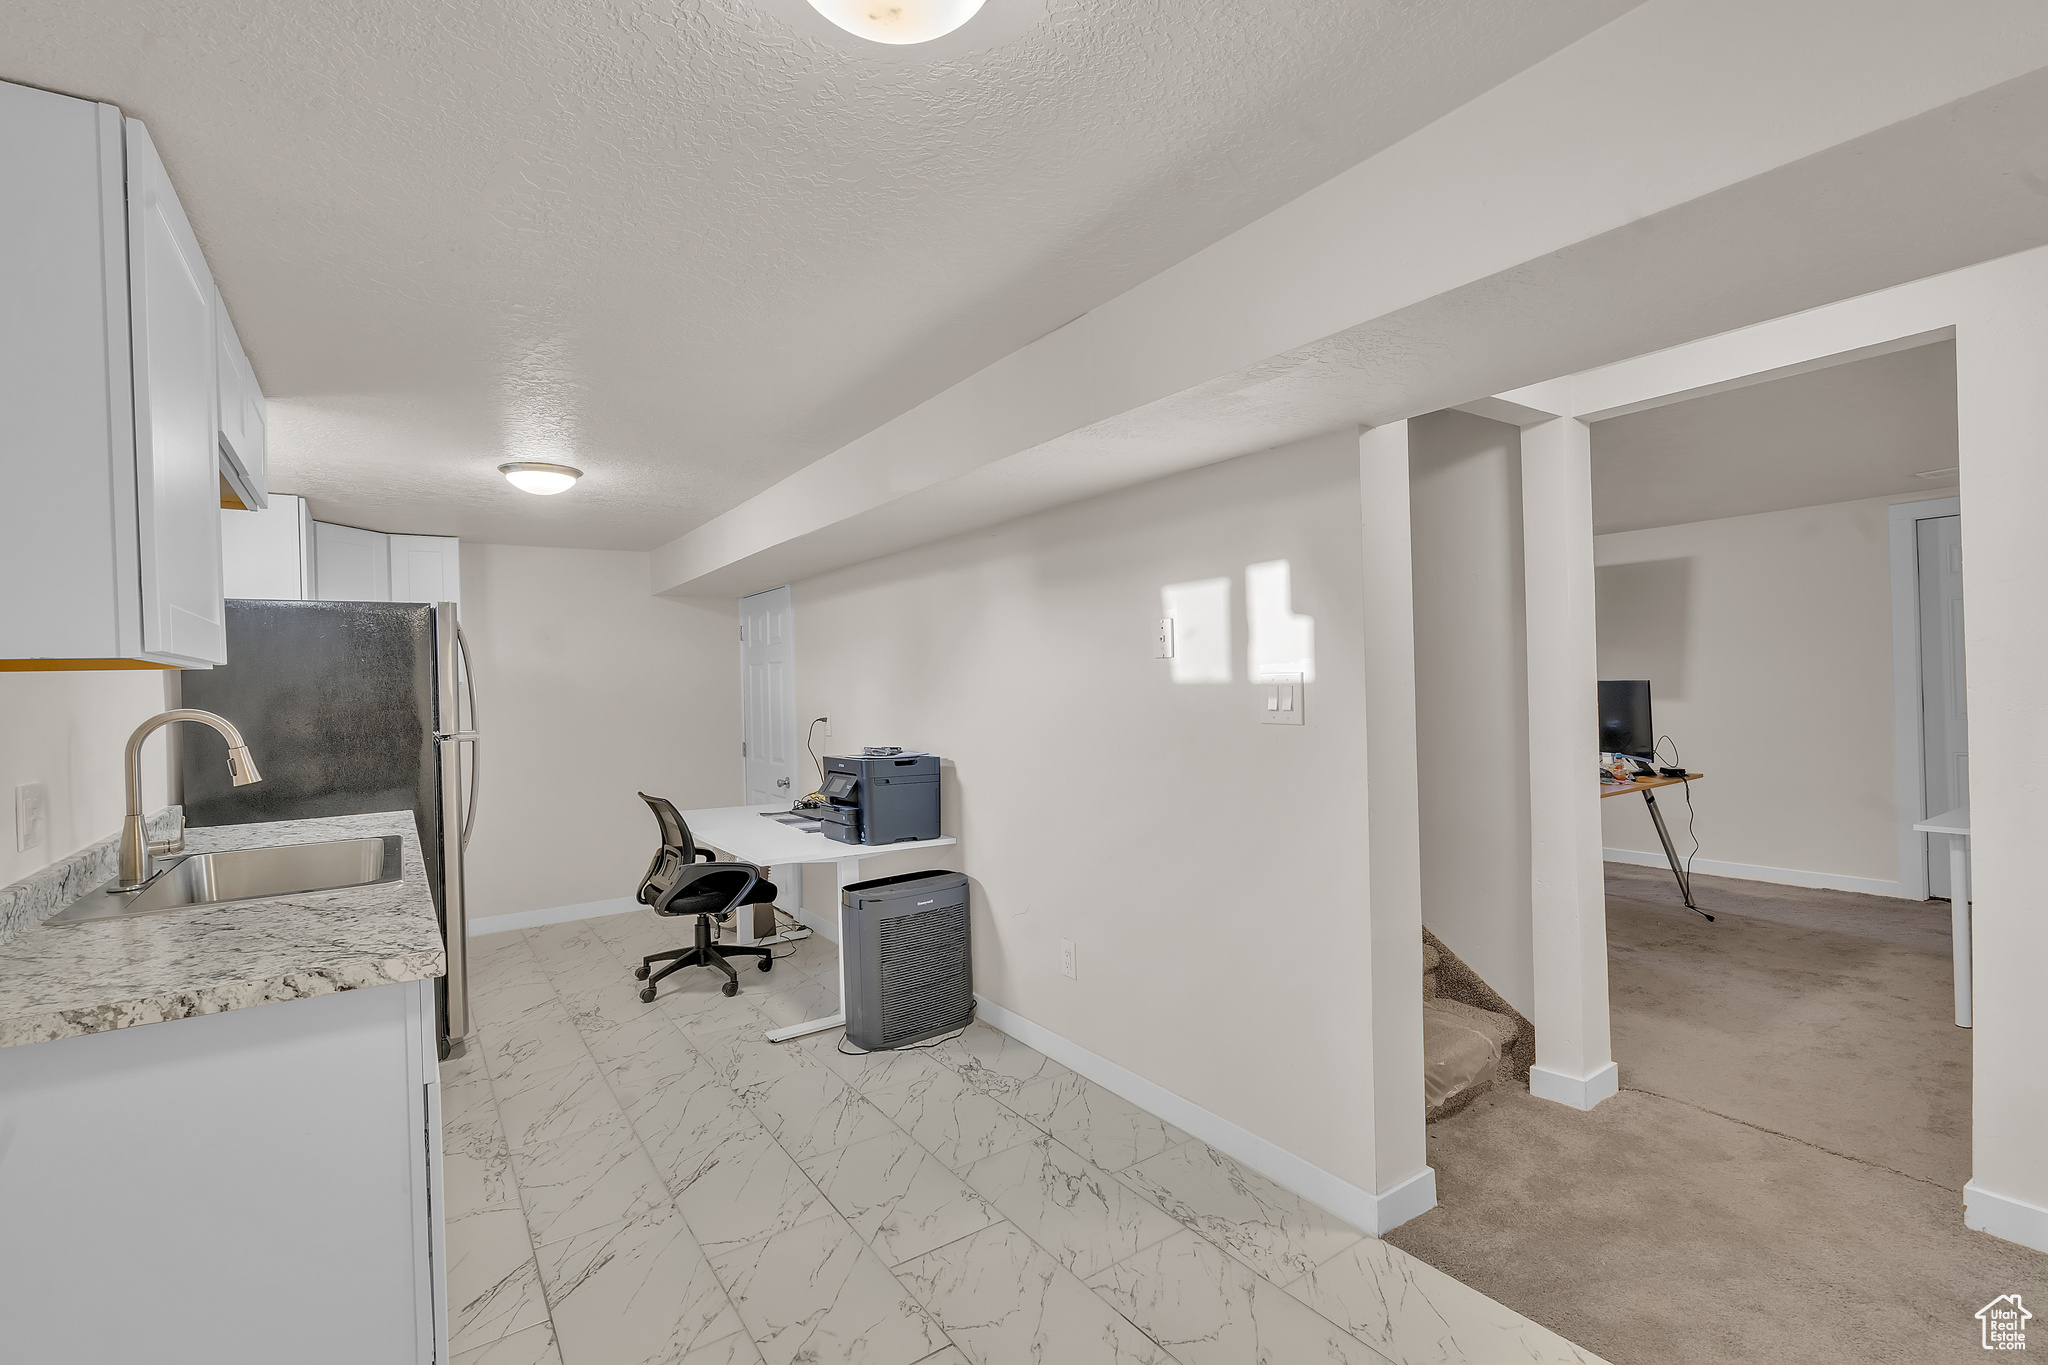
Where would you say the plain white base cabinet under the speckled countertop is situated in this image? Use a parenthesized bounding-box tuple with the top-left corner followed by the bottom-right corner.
(0, 980, 449, 1365)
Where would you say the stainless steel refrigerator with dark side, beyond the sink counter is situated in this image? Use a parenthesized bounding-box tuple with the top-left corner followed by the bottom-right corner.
(178, 598, 477, 1056)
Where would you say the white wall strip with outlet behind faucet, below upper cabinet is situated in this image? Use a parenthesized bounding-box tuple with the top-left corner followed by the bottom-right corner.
(0, 669, 166, 886)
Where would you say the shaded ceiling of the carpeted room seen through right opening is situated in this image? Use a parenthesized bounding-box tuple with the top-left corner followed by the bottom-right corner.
(1593, 342, 1956, 532)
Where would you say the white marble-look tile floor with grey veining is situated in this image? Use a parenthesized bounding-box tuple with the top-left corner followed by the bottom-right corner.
(442, 913, 1593, 1365)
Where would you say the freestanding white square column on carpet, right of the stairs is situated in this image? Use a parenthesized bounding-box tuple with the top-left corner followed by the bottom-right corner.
(1522, 417, 1620, 1109)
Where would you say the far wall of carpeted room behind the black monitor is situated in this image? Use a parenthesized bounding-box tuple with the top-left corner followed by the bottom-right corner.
(1595, 487, 1952, 894)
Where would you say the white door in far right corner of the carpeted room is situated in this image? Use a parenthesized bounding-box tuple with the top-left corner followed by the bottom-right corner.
(1915, 516, 1970, 896)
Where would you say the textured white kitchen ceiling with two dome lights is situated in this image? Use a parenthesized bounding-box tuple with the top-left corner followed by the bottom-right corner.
(0, 0, 1632, 548)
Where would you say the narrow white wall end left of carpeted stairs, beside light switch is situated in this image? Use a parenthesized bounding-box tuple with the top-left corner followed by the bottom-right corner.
(1358, 422, 1436, 1232)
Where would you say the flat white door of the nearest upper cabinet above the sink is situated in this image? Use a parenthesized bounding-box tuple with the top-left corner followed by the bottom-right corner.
(127, 119, 227, 663)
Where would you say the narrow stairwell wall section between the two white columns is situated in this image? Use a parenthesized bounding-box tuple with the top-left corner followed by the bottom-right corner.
(1409, 411, 1536, 1017)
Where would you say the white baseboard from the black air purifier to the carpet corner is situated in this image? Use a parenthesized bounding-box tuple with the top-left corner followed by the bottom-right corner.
(975, 995, 1436, 1236)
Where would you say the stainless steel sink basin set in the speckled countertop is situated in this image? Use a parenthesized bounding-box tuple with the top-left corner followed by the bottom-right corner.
(45, 835, 401, 925)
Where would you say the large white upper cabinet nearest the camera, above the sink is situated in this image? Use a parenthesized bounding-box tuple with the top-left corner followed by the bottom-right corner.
(0, 82, 237, 669)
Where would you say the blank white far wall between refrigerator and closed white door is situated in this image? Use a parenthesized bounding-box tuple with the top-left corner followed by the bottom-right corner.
(463, 542, 739, 919)
